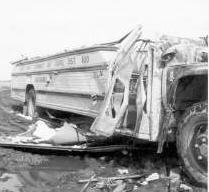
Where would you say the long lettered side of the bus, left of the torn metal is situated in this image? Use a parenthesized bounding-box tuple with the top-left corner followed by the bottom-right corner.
(12, 49, 116, 116)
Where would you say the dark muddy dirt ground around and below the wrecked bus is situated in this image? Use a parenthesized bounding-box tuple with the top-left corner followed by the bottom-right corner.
(0, 87, 207, 192)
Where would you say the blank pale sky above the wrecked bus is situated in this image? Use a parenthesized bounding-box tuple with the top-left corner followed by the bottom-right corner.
(0, 0, 209, 80)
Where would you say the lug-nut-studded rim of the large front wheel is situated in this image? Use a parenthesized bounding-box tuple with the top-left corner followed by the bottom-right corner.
(190, 122, 208, 173)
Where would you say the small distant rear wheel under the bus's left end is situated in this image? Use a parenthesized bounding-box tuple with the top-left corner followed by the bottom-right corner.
(26, 89, 36, 117)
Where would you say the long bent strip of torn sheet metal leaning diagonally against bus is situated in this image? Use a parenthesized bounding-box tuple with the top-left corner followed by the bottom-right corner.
(91, 26, 144, 137)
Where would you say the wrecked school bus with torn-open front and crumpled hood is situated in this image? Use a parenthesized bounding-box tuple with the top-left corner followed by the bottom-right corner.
(11, 26, 208, 184)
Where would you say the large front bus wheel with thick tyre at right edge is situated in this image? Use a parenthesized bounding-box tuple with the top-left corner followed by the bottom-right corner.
(177, 102, 208, 186)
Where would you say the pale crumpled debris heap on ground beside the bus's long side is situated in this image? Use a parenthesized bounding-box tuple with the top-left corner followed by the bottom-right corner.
(1, 120, 87, 145)
